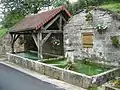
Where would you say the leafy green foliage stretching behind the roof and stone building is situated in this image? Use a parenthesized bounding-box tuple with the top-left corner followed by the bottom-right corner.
(0, 0, 120, 28)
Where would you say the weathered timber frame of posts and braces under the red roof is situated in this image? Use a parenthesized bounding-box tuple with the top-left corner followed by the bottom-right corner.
(10, 13, 67, 60)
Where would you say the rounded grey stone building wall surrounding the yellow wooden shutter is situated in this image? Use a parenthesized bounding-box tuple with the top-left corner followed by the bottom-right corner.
(64, 9, 120, 66)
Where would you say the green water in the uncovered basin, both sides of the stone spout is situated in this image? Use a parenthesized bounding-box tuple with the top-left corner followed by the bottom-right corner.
(44, 60, 110, 76)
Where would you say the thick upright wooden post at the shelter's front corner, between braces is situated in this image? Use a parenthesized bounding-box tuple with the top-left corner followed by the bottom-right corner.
(37, 31, 43, 60)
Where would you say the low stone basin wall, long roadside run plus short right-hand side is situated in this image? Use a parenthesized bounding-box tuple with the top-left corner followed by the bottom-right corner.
(7, 53, 120, 89)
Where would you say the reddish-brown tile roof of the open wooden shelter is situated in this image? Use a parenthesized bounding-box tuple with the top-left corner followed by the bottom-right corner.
(10, 6, 71, 32)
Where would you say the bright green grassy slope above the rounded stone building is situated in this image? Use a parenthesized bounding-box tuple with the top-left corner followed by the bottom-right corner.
(99, 2, 120, 14)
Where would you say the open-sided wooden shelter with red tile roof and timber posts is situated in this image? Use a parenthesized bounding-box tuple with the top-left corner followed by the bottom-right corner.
(9, 6, 70, 59)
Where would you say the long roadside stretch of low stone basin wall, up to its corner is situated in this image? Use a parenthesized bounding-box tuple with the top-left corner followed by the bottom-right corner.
(7, 53, 92, 88)
